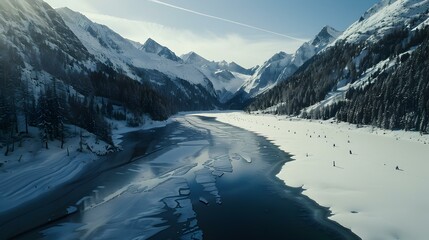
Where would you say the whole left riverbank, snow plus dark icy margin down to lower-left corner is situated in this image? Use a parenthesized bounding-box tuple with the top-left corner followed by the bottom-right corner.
(0, 118, 169, 236)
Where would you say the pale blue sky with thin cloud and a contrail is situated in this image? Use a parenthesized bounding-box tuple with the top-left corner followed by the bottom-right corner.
(46, 0, 378, 67)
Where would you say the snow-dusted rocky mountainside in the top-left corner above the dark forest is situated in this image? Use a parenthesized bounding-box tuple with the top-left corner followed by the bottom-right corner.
(0, 0, 95, 99)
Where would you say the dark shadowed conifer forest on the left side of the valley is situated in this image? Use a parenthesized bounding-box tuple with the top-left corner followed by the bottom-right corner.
(0, 41, 166, 155)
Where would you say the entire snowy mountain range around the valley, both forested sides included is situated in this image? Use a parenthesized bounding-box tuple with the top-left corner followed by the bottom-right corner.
(0, 0, 429, 142)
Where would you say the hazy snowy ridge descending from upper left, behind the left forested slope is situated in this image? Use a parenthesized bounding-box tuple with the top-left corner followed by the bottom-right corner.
(57, 8, 215, 95)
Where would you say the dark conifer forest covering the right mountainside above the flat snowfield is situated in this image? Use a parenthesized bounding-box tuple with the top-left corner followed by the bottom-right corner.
(246, 26, 429, 132)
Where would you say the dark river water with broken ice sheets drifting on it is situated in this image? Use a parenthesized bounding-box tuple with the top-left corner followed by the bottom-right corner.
(9, 117, 359, 239)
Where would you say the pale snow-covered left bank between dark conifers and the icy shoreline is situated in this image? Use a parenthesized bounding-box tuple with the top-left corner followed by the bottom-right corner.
(0, 119, 169, 213)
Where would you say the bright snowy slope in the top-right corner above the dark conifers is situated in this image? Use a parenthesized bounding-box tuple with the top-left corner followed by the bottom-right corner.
(338, 0, 429, 42)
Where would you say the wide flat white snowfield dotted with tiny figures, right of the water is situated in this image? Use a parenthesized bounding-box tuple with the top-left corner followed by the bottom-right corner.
(198, 112, 429, 240)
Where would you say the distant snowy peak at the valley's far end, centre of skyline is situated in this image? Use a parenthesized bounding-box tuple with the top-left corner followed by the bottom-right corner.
(181, 52, 253, 103)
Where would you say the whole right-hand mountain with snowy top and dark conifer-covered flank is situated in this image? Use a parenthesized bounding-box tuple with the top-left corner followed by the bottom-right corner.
(249, 0, 429, 132)
